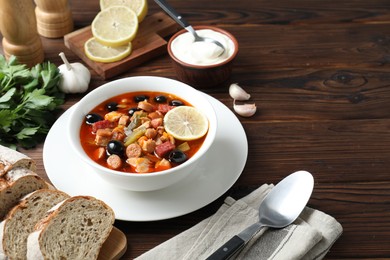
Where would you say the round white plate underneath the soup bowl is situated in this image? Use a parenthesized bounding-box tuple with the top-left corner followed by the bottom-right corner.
(43, 95, 248, 221)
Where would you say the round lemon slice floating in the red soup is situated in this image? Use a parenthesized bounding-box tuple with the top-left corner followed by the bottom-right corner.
(164, 106, 209, 141)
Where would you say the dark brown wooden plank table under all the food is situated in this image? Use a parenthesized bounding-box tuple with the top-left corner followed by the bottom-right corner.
(3, 0, 390, 259)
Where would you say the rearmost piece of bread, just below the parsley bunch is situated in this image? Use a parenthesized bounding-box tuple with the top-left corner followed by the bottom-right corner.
(0, 145, 37, 177)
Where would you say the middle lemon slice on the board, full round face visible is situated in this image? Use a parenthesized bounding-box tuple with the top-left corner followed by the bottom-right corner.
(91, 6, 138, 47)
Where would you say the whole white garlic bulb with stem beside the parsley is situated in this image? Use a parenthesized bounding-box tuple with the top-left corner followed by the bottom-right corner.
(58, 52, 91, 93)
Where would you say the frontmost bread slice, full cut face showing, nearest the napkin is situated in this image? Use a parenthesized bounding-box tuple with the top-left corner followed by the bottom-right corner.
(27, 196, 115, 260)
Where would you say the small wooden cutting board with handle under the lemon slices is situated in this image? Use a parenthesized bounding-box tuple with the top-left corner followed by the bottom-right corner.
(64, 12, 180, 79)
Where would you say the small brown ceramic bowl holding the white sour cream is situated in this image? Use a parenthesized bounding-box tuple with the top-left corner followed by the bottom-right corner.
(168, 25, 238, 89)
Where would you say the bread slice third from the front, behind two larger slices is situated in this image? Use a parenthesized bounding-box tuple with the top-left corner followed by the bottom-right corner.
(0, 167, 54, 220)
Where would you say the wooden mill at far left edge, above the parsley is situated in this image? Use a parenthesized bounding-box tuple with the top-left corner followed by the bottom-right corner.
(0, 0, 44, 67)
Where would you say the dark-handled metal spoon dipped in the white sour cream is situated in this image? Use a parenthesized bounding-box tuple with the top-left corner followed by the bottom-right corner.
(154, 0, 225, 56)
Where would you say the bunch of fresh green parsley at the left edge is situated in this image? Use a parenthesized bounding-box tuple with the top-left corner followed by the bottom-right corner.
(0, 55, 65, 149)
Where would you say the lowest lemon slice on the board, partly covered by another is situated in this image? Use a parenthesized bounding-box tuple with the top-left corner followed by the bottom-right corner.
(84, 37, 131, 63)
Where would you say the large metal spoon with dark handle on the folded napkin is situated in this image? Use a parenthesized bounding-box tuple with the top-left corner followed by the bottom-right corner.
(207, 171, 314, 260)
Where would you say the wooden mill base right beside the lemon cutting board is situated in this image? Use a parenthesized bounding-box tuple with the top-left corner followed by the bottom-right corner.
(35, 0, 73, 38)
